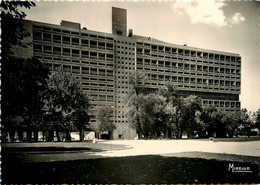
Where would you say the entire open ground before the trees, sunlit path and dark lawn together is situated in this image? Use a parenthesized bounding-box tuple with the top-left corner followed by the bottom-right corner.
(2, 140, 260, 183)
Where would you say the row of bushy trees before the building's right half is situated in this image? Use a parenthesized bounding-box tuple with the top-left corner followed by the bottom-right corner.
(127, 73, 260, 139)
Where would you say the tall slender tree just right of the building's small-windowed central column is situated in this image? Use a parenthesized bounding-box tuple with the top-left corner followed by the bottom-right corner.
(127, 72, 145, 139)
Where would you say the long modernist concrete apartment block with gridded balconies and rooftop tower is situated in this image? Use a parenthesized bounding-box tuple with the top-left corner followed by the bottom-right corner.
(16, 7, 241, 139)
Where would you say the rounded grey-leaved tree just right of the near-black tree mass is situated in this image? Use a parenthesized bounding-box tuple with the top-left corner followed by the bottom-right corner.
(44, 68, 90, 141)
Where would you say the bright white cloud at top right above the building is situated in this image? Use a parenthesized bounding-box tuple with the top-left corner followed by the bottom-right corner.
(172, 0, 245, 27)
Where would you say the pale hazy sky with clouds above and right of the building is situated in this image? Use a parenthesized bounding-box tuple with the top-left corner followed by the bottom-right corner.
(21, 0, 260, 111)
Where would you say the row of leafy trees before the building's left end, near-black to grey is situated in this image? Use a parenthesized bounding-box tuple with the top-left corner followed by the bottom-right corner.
(2, 57, 90, 142)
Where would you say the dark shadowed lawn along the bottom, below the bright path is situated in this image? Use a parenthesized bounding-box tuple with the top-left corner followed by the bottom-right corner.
(1, 155, 260, 184)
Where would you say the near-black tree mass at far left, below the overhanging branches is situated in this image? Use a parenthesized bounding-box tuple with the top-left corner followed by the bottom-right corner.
(2, 57, 49, 142)
